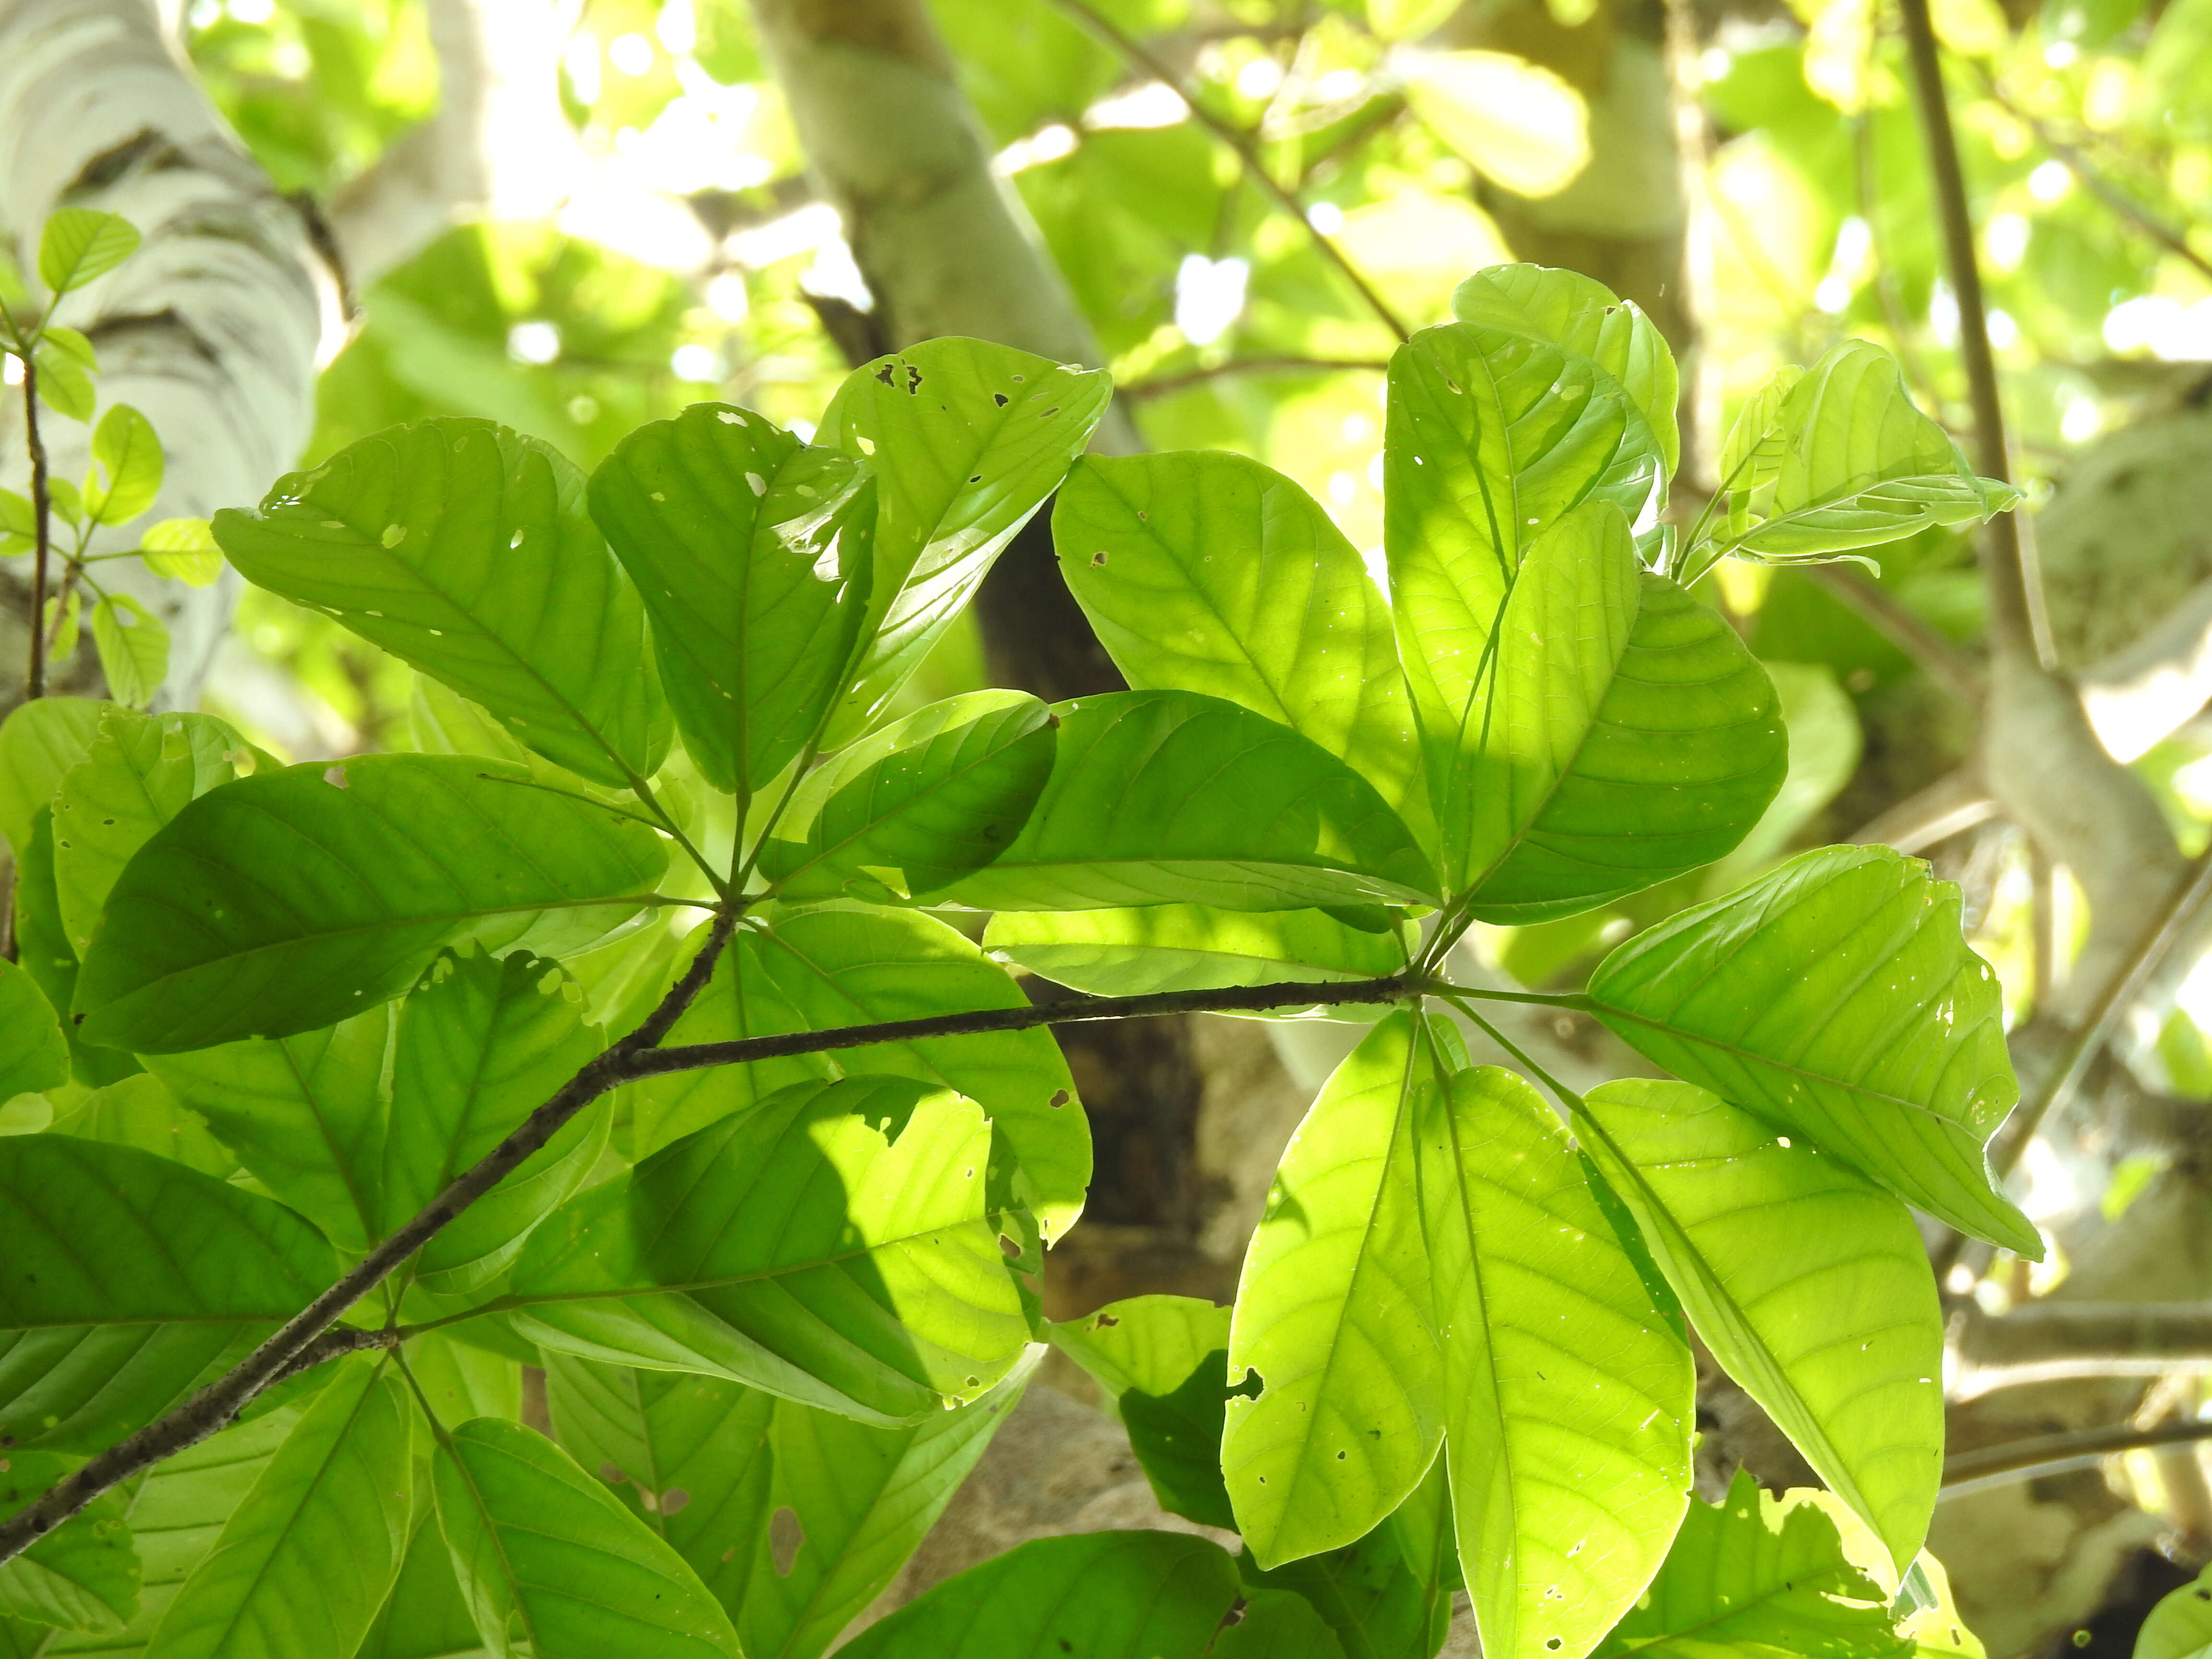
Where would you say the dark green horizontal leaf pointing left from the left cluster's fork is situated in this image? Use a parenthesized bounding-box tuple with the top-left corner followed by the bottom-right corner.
(75, 754, 668, 1053)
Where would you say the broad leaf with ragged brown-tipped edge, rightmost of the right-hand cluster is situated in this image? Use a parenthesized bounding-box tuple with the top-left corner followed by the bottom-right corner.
(1588, 847, 2044, 1261)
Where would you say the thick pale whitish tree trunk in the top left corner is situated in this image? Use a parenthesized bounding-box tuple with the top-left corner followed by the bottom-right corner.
(0, 0, 345, 708)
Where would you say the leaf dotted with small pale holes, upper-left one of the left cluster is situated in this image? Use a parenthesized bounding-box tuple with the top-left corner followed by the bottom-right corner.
(215, 418, 668, 787)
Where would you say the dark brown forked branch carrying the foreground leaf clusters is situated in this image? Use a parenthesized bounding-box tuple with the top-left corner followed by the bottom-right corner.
(0, 955, 1420, 1562)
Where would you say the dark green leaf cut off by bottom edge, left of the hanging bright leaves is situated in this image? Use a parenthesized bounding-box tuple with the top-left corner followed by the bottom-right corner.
(838, 1533, 1237, 1659)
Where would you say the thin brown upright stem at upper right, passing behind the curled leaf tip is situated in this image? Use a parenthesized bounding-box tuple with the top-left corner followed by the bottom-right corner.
(1898, 0, 2057, 668)
